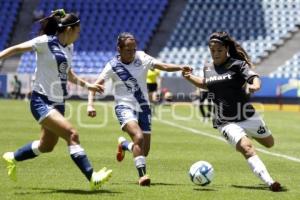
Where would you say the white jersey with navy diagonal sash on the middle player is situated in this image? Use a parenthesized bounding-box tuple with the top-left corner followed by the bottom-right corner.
(100, 51, 158, 111)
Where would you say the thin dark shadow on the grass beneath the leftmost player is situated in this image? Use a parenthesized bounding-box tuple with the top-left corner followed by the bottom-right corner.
(15, 187, 122, 195)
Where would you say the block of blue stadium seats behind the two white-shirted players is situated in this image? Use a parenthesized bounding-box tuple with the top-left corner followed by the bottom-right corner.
(18, 0, 168, 74)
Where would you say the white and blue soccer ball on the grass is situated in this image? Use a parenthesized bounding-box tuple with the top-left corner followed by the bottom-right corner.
(189, 160, 214, 186)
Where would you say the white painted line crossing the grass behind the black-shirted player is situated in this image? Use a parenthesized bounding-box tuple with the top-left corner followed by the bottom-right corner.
(157, 119, 300, 163)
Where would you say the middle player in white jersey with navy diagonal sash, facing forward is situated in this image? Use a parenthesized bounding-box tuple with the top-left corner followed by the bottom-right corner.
(87, 33, 191, 186)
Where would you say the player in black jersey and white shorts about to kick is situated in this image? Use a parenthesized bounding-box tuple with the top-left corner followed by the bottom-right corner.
(182, 32, 282, 192)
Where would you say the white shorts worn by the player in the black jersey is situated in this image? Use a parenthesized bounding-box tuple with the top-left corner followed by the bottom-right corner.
(218, 113, 272, 147)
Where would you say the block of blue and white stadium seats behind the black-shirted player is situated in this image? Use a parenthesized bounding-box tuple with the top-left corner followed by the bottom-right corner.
(159, 0, 300, 76)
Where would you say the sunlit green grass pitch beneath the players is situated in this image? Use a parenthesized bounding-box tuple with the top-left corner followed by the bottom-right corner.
(0, 100, 300, 200)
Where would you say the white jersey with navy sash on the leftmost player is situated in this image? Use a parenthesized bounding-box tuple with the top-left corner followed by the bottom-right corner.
(29, 35, 73, 102)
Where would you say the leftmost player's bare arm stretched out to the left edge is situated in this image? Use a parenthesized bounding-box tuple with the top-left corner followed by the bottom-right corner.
(0, 41, 33, 60)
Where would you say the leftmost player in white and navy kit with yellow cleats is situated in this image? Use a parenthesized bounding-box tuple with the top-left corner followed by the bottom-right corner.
(0, 9, 112, 190)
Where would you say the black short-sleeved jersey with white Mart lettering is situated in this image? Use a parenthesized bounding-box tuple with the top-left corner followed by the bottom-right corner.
(203, 58, 258, 128)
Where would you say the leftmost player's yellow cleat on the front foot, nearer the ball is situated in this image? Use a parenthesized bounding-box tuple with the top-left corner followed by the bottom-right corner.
(90, 167, 112, 190)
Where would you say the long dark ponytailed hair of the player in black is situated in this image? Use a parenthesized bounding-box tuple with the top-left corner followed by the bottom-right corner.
(209, 32, 253, 68)
